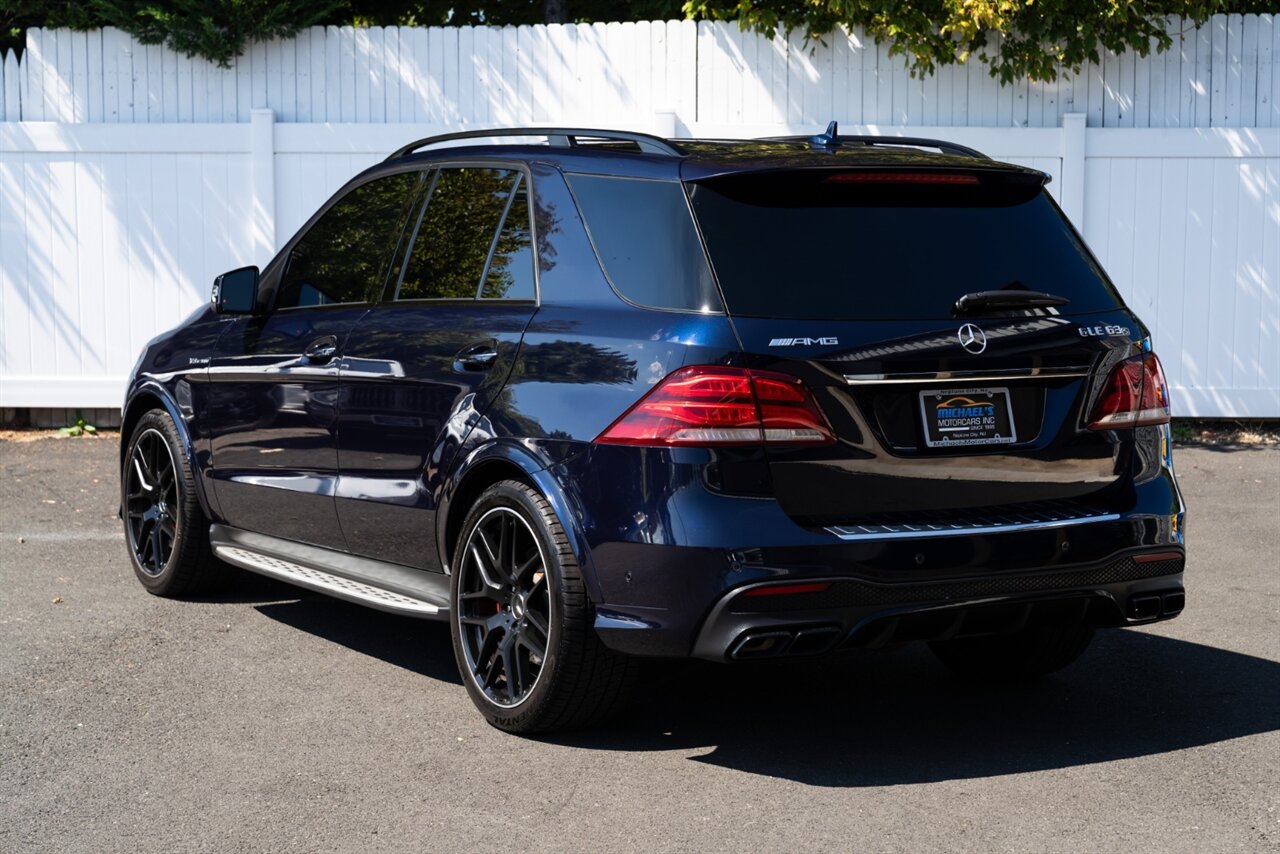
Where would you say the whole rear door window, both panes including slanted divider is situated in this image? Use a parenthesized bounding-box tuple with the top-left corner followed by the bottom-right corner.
(396, 166, 534, 300)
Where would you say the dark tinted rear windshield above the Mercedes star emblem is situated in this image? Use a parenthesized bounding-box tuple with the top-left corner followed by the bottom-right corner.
(691, 170, 1119, 320)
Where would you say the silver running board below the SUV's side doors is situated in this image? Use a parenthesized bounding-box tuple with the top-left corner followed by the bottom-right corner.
(209, 525, 449, 620)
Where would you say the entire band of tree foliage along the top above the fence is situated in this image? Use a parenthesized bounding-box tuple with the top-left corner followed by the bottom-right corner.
(0, 0, 1280, 82)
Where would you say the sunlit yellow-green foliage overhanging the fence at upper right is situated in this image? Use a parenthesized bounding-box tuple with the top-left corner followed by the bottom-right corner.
(685, 0, 1280, 83)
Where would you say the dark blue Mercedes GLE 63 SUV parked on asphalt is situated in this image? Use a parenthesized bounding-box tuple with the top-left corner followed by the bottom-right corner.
(120, 124, 1184, 732)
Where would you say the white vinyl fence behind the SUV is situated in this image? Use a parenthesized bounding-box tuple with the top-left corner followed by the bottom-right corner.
(0, 15, 1280, 417)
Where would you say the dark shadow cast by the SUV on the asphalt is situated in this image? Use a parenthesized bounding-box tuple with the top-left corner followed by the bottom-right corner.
(222, 574, 1280, 787)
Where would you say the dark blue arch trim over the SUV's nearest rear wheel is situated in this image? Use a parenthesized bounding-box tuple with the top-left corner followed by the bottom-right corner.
(435, 443, 600, 602)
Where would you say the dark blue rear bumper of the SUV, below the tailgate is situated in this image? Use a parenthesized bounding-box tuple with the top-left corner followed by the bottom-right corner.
(558, 453, 1185, 661)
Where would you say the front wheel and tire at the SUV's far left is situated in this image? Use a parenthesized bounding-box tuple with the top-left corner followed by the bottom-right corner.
(120, 410, 234, 597)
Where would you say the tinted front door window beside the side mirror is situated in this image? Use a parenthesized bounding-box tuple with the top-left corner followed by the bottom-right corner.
(275, 172, 421, 309)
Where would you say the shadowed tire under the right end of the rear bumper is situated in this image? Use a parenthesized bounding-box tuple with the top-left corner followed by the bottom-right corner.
(929, 624, 1093, 682)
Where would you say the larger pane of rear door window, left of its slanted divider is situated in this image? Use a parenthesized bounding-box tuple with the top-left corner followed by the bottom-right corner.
(396, 168, 519, 300)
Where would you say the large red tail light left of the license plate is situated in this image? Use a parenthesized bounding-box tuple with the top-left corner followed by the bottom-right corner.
(595, 366, 835, 446)
